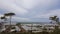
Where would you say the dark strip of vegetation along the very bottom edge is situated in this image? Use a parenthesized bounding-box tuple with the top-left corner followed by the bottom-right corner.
(0, 31, 60, 34)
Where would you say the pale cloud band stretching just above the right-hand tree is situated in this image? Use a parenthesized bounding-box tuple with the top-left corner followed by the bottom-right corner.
(35, 9, 60, 18)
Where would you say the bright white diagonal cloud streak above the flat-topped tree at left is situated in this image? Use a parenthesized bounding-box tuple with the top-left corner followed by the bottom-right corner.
(0, 0, 27, 15)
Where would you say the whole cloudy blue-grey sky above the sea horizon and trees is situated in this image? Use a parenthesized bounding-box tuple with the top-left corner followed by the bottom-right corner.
(0, 0, 60, 22)
